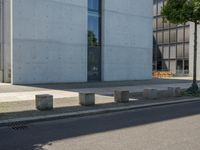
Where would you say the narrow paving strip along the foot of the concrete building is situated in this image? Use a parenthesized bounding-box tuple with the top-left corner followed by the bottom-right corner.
(0, 78, 200, 93)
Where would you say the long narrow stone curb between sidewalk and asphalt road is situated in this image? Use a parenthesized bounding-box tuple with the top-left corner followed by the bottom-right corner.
(0, 98, 200, 127)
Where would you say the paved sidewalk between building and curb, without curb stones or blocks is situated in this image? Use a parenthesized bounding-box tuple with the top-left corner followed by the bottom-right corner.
(0, 79, 199, 126)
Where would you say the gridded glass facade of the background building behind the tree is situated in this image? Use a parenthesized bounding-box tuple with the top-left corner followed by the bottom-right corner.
(153, 0, 189, 76)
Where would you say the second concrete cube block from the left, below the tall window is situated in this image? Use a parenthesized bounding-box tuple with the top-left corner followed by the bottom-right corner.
(79, 93, 95, 106)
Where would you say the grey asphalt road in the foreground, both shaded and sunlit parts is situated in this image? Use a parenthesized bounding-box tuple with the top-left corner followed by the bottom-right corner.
(0, 102, 200, 150)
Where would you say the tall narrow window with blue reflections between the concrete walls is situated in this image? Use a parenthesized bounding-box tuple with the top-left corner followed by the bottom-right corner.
(88, 0, 101, 81)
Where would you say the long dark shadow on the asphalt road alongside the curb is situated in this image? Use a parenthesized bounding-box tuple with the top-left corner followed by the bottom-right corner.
(0, 102, 200, 150)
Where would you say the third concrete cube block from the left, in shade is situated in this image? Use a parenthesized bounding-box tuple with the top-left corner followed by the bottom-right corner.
(114, 91, 129, 103)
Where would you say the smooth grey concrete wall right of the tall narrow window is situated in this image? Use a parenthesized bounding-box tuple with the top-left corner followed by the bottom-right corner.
(103, 0, 153, 81)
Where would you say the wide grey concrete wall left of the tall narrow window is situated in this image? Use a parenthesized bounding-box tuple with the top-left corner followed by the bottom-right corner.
(13, 0, 87, 84)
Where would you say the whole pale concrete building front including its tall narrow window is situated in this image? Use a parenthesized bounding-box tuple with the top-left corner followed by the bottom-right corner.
(0, 0, 153, 84)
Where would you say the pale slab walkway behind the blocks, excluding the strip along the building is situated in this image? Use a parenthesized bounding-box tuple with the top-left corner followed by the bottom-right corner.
(0, 83, 198, 102)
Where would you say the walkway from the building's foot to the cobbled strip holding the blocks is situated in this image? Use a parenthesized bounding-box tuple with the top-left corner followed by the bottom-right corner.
(0, 79, 198, 102)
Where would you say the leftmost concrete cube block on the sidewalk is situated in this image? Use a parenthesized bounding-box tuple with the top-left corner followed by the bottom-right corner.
(35, 94, 53, 111)
